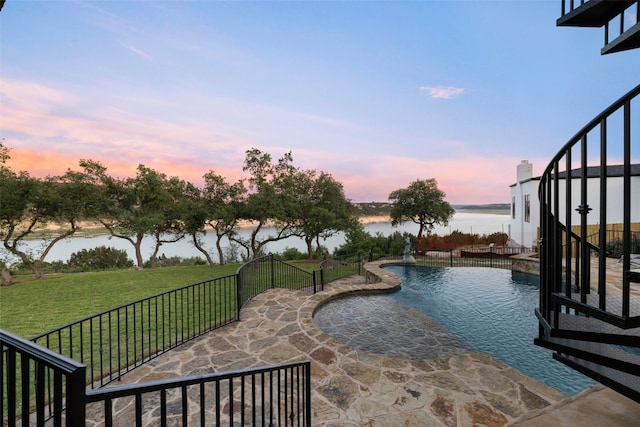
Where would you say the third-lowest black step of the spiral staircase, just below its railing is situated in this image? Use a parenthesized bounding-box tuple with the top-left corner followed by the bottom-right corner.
(549, 313, 640, 347)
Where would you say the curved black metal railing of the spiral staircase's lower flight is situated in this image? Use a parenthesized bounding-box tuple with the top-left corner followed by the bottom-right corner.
(539, 86, 640, 328)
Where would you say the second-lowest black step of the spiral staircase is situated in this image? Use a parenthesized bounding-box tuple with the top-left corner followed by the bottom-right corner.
(534, 337, 640, 378)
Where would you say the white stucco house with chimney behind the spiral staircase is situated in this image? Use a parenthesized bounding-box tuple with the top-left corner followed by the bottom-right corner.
(509, 160, 640, 248)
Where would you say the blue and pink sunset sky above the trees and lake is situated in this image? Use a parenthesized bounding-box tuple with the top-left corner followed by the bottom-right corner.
(0, 0, 640, 204)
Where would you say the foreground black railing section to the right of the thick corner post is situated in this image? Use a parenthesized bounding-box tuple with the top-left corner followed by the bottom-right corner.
(87, 361, 311, 427)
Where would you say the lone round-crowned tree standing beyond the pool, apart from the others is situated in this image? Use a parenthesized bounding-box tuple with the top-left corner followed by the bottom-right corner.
(389, 178, 455, 240)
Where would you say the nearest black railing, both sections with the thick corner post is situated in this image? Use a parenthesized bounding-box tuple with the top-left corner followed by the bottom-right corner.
(0, 330, 311, 427)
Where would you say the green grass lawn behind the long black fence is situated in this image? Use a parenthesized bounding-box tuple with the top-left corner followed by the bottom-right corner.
(0, 262, 318, 338)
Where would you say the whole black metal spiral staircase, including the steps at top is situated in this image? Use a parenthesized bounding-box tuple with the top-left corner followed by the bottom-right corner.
(535, 0, 640, 402)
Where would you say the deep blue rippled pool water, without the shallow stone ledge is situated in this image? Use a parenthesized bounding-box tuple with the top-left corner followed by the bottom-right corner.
(384, 265, 594, 396)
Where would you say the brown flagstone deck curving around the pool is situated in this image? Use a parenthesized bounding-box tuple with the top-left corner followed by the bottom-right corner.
(106, 263, 640, 427)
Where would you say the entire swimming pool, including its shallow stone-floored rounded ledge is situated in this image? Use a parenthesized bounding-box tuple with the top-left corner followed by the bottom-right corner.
(314, 265, 594, 396)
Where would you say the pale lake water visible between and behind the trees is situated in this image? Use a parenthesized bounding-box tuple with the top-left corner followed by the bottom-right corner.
(8, 212, 510, 262)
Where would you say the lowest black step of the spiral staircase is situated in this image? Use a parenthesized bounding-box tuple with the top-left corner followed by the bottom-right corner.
(553, 353, 640, 402)
